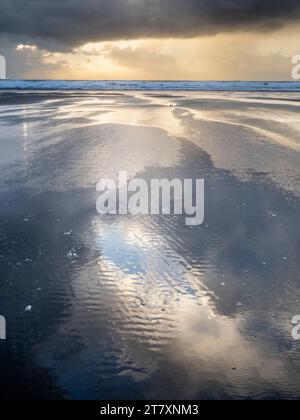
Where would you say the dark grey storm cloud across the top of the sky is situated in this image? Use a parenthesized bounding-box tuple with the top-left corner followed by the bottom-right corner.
(0, 0, 300, 47)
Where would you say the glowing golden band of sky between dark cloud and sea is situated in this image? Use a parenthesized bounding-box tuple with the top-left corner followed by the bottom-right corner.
(11, 26, 300, 80)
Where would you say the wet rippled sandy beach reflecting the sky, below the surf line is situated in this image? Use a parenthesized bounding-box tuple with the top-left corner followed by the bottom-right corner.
(0, 92, 300, 399)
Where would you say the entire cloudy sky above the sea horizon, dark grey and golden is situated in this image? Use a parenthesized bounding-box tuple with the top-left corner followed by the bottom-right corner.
(0, 0, 300, 80)
